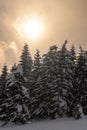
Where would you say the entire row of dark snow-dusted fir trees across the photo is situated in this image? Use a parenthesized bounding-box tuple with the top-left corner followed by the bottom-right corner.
(0, 41, 87, 125)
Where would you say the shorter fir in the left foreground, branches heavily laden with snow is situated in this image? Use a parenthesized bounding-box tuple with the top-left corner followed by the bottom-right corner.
(0, 65, 30, 125)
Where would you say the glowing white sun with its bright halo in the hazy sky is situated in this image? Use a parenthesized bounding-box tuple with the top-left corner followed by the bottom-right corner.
(15, 18, 44, 39)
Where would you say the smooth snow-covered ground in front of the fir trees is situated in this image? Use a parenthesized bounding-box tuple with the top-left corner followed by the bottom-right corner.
(0, 118, 87, 130)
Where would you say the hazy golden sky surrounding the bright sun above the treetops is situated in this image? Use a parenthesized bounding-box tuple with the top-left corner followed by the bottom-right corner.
(0, 0, 87, 69)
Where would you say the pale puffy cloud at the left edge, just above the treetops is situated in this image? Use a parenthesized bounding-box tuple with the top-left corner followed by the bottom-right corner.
(0, 41, 19, 70)
